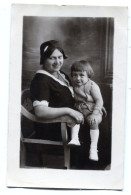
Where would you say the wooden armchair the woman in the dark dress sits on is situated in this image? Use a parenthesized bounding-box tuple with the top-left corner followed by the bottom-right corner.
(21, 89, 73, 169)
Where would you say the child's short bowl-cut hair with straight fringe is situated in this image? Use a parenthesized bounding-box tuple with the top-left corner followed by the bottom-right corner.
(71, 60, 94, 78)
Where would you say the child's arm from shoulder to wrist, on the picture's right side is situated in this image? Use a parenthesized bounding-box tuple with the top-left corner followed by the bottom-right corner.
(91, 83, 103, 110)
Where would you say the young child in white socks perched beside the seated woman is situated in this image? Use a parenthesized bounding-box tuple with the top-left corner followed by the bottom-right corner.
(68, 60, 106, 161)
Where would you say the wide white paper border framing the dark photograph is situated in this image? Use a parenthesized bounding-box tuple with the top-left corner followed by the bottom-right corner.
(7, 5, 127, 189)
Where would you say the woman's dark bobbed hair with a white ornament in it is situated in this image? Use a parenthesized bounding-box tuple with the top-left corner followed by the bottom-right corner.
(40, 40, 67, 65)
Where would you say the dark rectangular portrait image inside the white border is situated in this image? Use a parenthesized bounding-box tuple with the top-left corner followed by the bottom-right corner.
(20, 16, 114, 170)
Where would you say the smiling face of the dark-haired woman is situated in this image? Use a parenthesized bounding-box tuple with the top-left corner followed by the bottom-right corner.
(43, 49, 64, 74)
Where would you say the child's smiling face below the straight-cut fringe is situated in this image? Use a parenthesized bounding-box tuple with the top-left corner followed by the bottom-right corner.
(72, 71, 89, 86)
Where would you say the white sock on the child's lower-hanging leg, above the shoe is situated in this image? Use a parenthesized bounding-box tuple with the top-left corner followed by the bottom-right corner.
(90, 129, 99, 149)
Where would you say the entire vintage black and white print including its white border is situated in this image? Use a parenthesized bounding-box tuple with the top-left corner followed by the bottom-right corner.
(8, 5, 127, 189)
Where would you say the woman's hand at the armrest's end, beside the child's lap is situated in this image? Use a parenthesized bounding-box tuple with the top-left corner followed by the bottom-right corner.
(68, 108, 84, 124)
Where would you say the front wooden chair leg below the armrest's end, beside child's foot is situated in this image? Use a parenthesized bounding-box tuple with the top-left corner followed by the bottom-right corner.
(61, 123, 70, 169)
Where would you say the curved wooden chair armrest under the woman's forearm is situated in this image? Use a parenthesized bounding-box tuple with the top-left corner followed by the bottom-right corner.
(21, 105, 75, 123)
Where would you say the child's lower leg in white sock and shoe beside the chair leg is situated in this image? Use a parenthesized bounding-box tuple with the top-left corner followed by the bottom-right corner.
(68, 125, 80, 146)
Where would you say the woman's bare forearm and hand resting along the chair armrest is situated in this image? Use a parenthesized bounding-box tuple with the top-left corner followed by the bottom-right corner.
(34, 105, 84, 123)
